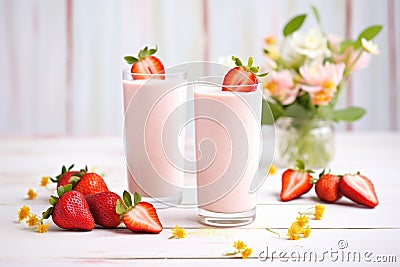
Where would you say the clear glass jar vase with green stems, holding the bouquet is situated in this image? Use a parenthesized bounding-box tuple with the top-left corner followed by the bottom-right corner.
(275, 117, 335, 169)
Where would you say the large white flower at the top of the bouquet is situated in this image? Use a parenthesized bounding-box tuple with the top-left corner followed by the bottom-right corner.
(281, 28, 331, 67)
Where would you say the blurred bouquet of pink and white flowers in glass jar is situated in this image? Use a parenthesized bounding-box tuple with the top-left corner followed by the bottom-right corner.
(262, 6, 382, 168)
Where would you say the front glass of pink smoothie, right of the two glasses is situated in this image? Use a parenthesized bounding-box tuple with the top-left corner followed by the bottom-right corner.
(194, 78, 262, 226)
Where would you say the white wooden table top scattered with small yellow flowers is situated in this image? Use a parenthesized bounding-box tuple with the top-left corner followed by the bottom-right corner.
(0, 133, 400, 266)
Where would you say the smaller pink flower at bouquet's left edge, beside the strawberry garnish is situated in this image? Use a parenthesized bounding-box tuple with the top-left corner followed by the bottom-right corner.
(263, 70, 300, 105)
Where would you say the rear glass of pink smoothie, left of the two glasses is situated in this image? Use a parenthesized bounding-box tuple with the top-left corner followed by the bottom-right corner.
(123, 70, 187, 208)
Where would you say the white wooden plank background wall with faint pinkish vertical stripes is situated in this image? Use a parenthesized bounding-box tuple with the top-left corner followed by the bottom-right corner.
(0, 0, 400, 135)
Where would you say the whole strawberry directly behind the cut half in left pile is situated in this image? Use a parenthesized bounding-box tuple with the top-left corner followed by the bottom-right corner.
(86, 191, 121, 228)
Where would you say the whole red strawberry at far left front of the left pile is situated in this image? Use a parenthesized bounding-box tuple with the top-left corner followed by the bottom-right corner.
(42, 184, 94, 231)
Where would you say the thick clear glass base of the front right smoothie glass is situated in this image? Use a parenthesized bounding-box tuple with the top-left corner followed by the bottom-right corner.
(199, 208, 256, 227)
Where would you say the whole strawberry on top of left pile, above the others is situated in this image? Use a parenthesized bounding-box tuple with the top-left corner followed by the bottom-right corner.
(69, 167, 108, 196)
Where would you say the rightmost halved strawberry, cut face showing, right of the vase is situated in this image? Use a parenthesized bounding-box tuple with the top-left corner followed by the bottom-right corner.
(339, 173, 379, 208)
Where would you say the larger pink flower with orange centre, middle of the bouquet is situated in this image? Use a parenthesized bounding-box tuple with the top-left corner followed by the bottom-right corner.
(299, 62, 345, 105)
